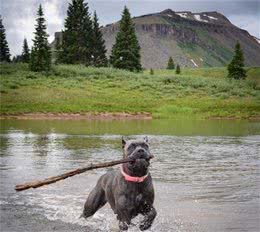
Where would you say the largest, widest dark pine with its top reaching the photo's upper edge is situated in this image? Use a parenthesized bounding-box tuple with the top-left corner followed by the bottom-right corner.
(59, 0, 93, 65)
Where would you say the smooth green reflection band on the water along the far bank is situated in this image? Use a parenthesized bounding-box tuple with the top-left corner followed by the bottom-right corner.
(0, 118, 260, 136)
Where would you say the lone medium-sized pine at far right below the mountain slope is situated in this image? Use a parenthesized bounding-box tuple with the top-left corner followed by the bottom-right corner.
(227, 42, 246, 79)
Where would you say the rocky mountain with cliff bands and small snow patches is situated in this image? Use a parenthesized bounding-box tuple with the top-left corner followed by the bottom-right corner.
(52, 9, 260, 69)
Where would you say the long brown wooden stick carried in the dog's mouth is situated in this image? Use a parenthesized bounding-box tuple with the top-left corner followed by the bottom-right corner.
(15, 159, 133, 191)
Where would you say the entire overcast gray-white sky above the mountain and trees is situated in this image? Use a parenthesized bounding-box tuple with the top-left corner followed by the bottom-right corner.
(0, 0, 260, 55)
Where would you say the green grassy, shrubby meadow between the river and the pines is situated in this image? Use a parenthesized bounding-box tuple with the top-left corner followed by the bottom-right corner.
(0, 64, 260, 118)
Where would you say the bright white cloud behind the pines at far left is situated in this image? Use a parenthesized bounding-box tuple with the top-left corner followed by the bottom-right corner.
(1, 0, 67, 55)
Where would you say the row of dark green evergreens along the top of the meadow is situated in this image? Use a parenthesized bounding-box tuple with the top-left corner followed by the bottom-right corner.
(0, 0, 246, 79)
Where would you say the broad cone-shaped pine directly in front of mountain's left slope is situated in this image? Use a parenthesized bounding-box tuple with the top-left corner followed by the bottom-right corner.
(110, 7, 142, 71)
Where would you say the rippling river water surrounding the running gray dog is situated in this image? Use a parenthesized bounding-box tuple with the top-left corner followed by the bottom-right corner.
(0, 119, 260, 232)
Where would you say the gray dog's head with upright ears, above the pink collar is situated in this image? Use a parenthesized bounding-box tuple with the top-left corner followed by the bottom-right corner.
(122, 137, 153, 176)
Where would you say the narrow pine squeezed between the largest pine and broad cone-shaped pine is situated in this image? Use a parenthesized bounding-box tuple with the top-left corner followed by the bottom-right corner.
(92, 11, 107, 67)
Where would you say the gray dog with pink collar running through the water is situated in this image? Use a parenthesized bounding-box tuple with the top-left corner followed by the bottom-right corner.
(82, 137, 156, 230)
